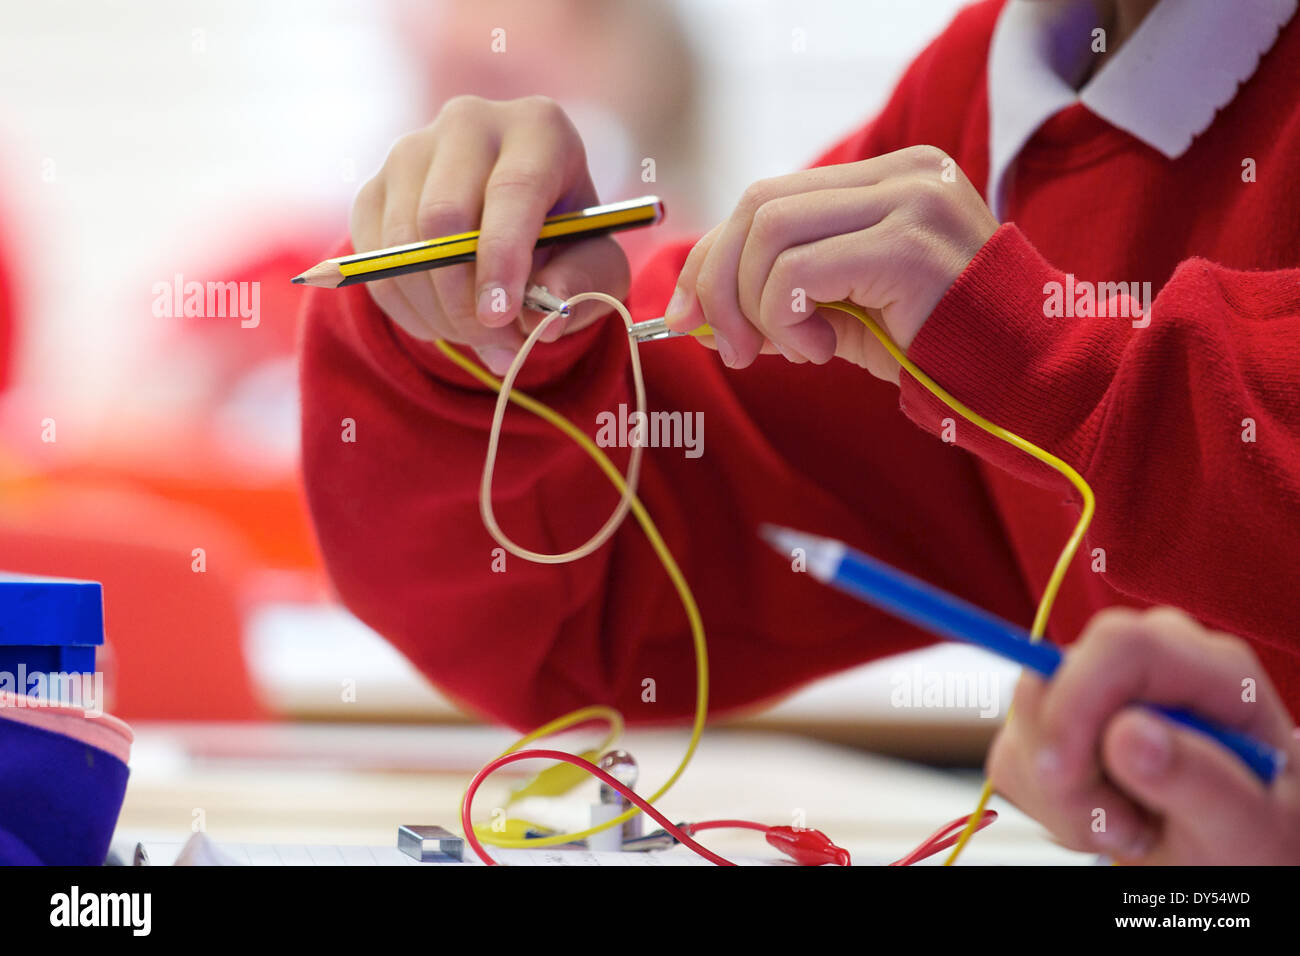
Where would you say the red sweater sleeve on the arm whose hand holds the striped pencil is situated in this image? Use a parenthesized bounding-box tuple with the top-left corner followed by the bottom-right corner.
(302, 9, 1030, 727)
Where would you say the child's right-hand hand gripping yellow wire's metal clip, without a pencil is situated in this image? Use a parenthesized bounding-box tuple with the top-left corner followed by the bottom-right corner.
(666, 146, 997, 382)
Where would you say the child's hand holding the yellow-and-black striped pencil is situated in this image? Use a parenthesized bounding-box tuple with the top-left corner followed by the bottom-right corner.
(352, 96, 628, 375)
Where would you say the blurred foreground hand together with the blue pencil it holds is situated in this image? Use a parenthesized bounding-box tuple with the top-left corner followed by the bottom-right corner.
(762, 525, 1300, 865)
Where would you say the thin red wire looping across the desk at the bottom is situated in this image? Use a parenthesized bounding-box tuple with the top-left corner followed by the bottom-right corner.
(460, 750, 997, 866)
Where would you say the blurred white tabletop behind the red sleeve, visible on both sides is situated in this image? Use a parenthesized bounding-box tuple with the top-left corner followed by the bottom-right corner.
(244, 602, 1019, 763)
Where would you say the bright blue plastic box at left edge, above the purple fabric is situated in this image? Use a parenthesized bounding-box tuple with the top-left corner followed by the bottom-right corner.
(0, 572, 104, 692)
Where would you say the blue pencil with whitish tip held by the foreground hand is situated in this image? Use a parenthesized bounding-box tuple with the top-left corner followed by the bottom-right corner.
(761, 524, 1287, 783)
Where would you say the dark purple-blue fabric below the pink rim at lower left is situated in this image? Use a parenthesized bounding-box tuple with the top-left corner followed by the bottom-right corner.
(0, 719, 129, 866)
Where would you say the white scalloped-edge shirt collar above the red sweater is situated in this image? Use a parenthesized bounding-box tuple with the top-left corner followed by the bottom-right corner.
(988, 0, 1297, 220)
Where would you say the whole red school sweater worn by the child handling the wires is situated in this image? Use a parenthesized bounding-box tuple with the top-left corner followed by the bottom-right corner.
(303, 3, 1300, 727)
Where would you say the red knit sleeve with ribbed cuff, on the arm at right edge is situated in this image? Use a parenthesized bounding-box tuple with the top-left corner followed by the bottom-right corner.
(902, 225, 1300, 648)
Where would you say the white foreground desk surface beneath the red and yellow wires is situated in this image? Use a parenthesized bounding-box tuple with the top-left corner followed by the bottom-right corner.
(114, 723, 1093, 864)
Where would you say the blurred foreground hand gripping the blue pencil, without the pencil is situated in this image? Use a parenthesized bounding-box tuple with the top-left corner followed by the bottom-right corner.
(988, 607, 1300, 864)
